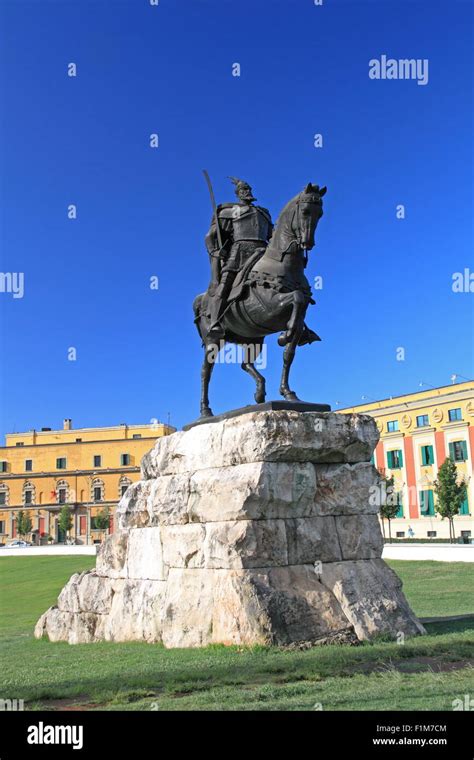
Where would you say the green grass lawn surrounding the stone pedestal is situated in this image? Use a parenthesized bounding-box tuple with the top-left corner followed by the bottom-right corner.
(0, 557, 474, 710)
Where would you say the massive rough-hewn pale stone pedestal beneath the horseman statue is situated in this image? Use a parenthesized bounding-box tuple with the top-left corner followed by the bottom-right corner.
(35, 411, 424, 647)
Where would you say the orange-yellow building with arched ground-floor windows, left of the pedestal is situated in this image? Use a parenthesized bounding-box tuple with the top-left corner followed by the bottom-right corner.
(0, 419, 175, 544)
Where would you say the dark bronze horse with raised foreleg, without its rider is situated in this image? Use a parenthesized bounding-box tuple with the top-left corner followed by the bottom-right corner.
(193, 183, 326, 417)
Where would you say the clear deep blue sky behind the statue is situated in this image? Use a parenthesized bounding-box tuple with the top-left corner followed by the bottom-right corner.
(0, 0, 474, 435)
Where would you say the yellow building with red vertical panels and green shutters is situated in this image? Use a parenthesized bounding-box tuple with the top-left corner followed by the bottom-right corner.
(339, 380, 474, 540)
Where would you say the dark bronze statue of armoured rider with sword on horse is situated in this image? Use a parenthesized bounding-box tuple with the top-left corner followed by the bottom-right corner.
(193, 173, 326, 417)
